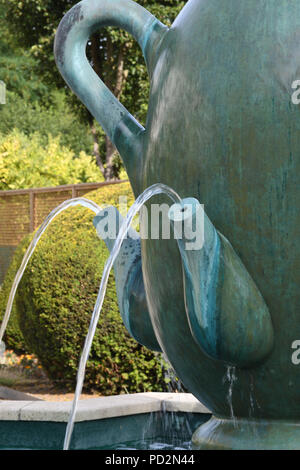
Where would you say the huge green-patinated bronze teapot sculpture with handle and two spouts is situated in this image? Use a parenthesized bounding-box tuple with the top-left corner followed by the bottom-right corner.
(55, 0, 300, 449)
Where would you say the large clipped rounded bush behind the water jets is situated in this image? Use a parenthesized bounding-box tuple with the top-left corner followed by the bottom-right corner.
(0, 183, 167, 395)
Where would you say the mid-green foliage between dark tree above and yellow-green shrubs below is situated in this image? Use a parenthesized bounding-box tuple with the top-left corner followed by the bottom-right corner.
(0, 3, 95, 164)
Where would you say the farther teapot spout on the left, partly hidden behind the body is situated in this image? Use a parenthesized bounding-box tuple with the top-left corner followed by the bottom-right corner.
(93, 206, 161, 352)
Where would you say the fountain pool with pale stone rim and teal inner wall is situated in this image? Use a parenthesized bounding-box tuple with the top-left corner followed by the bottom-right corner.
(0, 392, 211, 450)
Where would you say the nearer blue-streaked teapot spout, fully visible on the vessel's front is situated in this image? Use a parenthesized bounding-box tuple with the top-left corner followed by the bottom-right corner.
(169, 198, 273, 368)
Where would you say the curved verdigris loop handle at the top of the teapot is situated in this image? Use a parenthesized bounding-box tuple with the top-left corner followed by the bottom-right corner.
(54, 0, 168, 178)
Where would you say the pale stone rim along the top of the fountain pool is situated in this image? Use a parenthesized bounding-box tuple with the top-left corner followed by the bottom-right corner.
(0, 392, 211, 422)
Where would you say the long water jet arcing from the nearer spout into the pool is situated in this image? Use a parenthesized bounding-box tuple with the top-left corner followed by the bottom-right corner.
(63, 183, 181, 450)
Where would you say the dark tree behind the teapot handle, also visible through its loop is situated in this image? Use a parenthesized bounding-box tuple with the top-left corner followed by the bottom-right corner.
(0, 0, 186, 179)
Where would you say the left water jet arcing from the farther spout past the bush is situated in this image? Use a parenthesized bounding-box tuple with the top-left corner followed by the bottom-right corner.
(0, 197, 101, 344)
